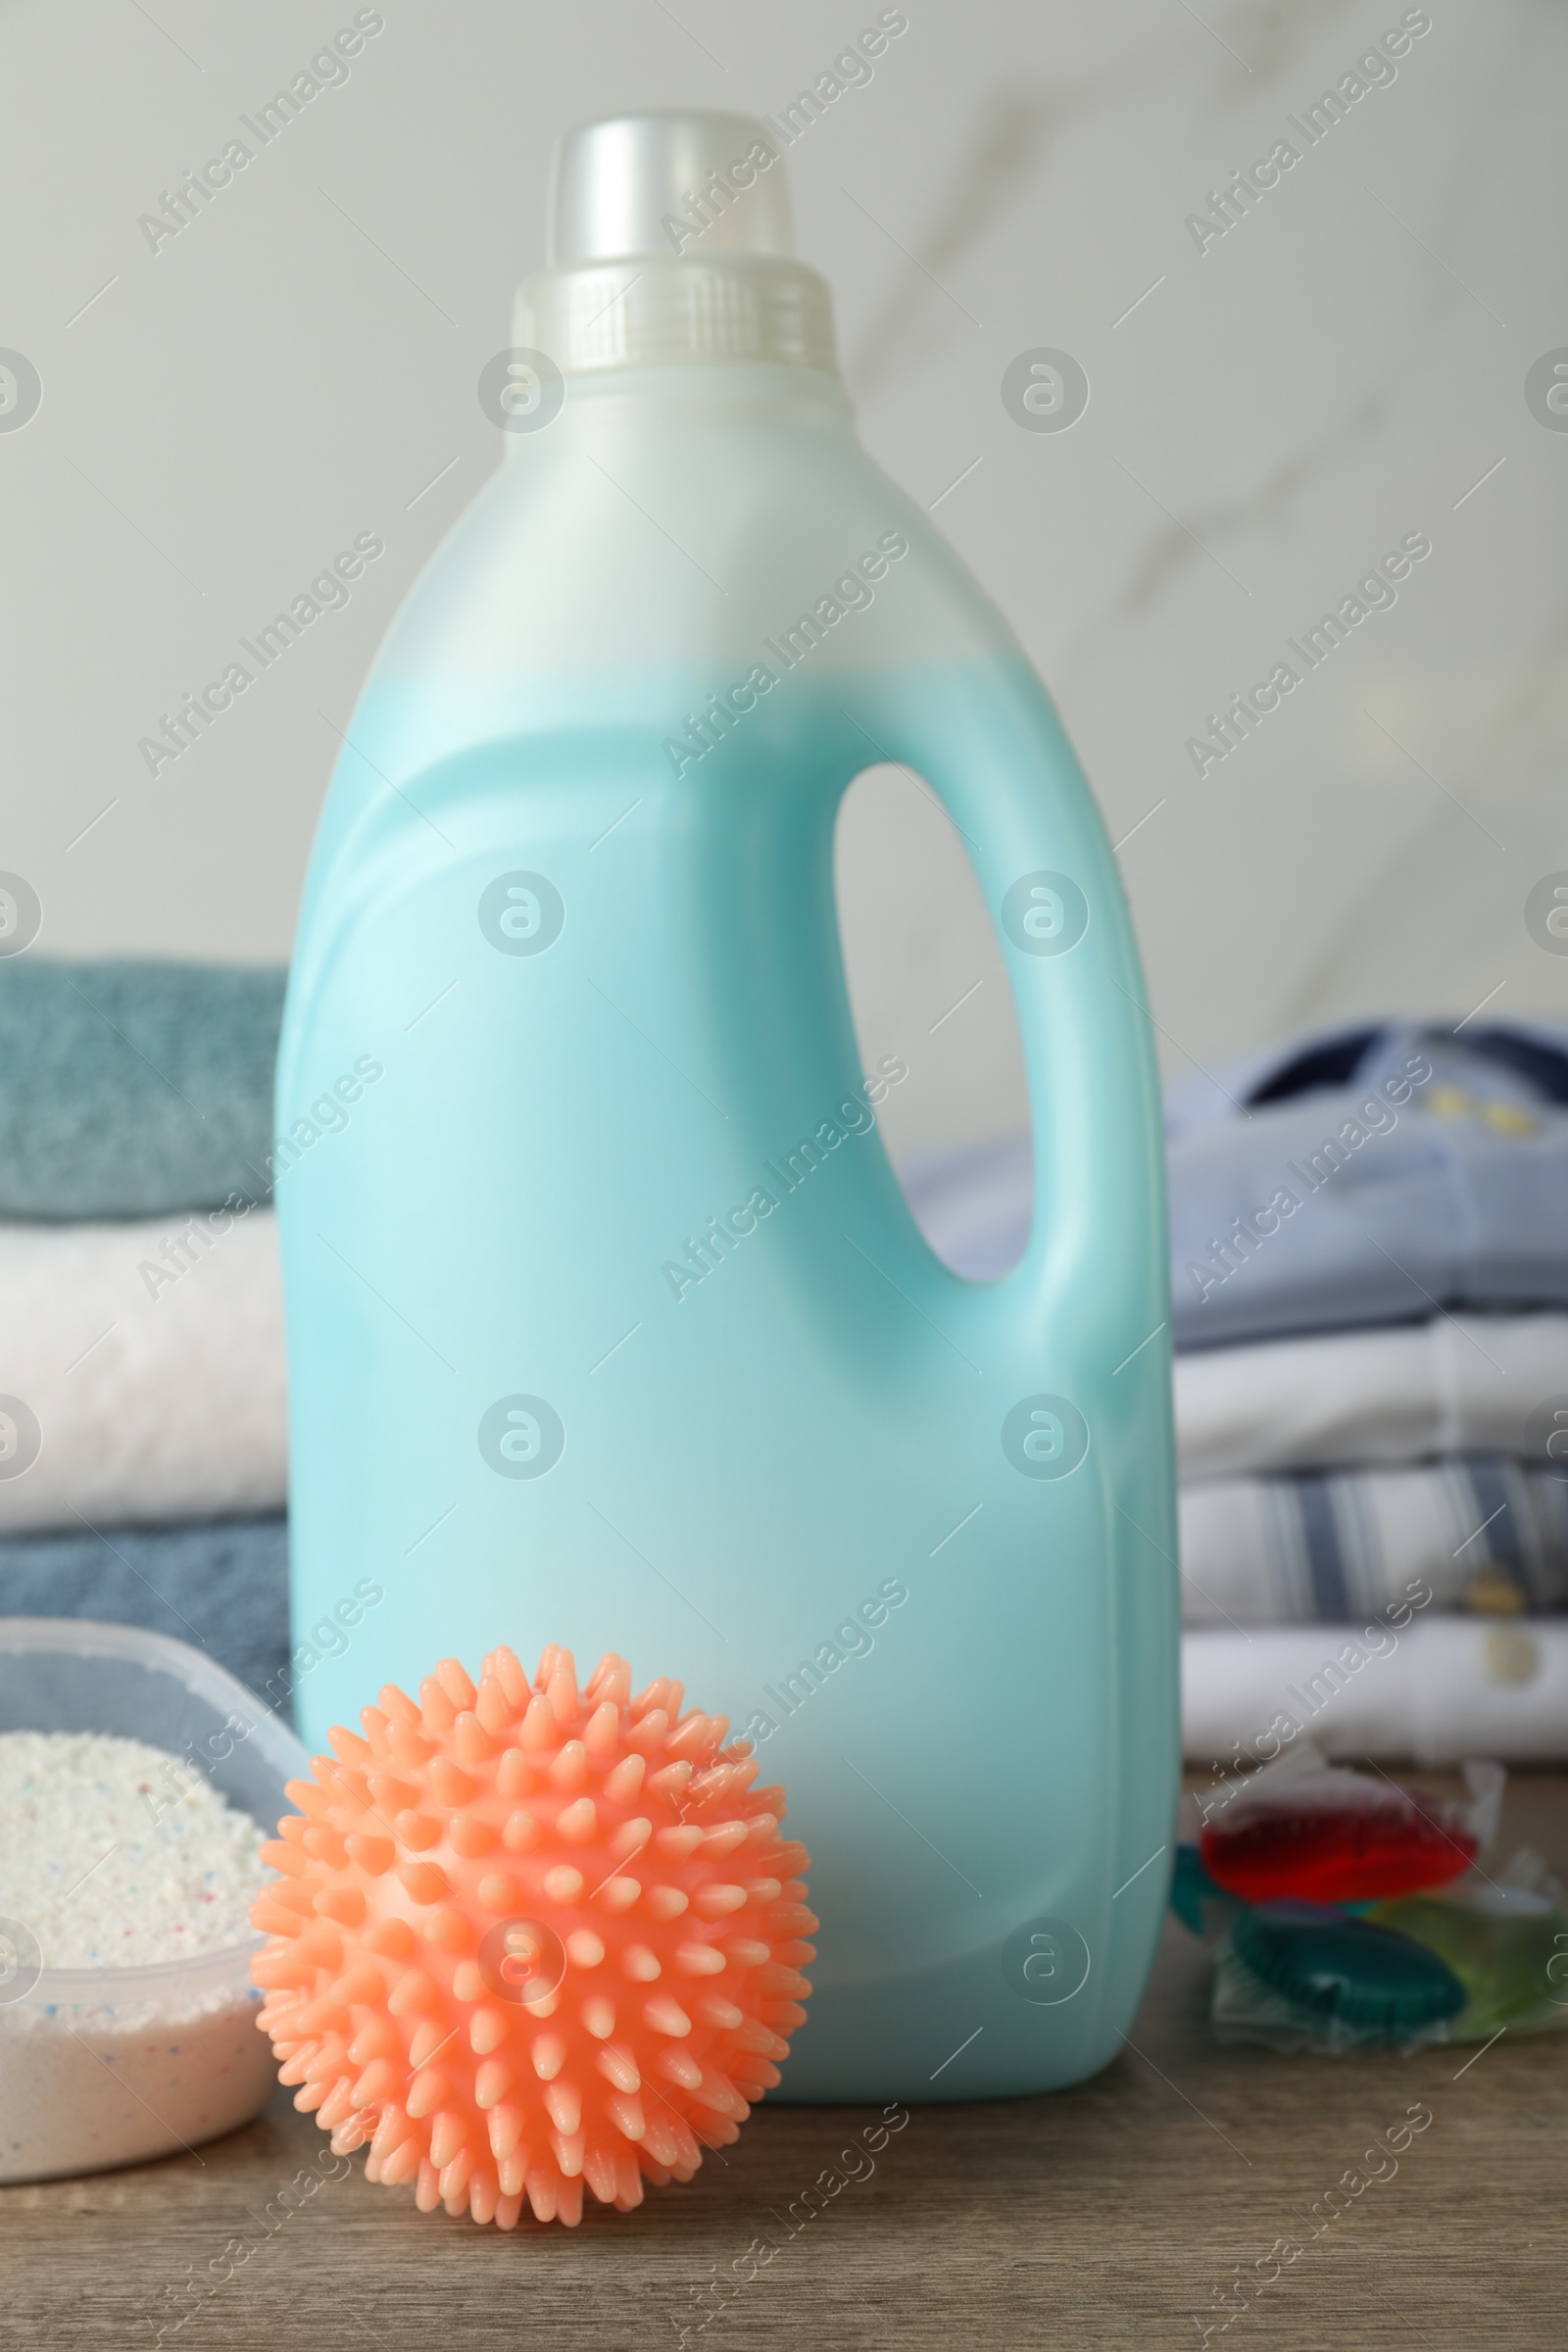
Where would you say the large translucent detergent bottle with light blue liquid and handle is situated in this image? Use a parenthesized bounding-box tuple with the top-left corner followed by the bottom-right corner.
(277, 113, 1178, 2100)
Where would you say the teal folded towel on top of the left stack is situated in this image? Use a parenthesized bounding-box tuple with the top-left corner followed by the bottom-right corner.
(0, 955, 287, 1221)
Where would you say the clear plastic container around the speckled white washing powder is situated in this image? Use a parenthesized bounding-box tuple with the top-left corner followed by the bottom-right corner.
(0, 1618, 308, 2180)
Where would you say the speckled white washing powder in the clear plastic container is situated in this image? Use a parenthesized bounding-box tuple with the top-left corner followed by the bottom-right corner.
(0, 1731, 275, 2180)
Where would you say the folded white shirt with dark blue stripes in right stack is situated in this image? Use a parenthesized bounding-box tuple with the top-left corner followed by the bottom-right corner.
(1180, 1456, 1568, 1625)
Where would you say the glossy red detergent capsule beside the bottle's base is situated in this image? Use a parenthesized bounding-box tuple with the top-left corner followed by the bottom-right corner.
(1199, 1769, 1479, 1903)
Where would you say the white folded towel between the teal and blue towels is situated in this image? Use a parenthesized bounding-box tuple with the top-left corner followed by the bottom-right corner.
(0, 1209, 287, 1536)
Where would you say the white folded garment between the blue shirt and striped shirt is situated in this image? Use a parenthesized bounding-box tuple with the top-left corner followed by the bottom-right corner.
(1175, 1315, 1568, 1480)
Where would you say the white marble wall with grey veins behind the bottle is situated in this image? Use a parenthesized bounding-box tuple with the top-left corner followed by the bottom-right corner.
(0, 0, 1568, 1146)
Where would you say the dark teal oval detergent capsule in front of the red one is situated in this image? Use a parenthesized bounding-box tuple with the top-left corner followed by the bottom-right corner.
(1232, 1903, 1467, 2041)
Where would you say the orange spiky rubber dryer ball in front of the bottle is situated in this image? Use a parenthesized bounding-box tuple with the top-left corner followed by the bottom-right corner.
(252, 1646, 815, 2230)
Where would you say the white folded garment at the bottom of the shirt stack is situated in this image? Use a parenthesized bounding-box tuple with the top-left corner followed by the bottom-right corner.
(1183, 1616, 1568, 1771)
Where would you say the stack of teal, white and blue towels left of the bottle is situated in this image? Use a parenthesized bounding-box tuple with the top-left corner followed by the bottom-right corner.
(0, 955, 287, 1689)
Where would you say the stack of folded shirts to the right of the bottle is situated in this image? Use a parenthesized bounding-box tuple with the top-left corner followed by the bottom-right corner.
(893, 1021, 1568, 1764)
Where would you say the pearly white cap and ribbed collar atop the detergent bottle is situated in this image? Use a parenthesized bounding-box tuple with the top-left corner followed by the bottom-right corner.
(513, 113, 837, 374)
